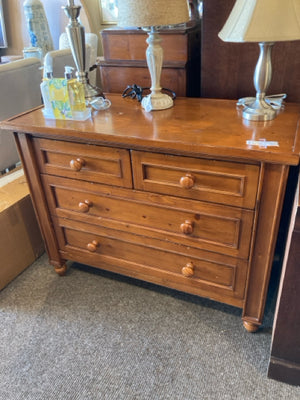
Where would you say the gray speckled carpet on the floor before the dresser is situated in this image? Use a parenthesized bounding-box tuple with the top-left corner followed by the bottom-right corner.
(0, 256, 300, 400)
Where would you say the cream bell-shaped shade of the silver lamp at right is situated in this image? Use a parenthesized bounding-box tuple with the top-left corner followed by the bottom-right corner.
(219, 0, 300, 42)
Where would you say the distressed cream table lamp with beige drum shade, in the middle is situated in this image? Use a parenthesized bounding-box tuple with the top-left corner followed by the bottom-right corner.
(118, 0, 189, 111)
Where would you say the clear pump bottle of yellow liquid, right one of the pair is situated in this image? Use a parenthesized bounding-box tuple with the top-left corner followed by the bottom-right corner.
(65, 66, 86, 119)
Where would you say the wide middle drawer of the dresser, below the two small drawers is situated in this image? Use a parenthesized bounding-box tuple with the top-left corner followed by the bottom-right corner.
(43, 176, 253, 259)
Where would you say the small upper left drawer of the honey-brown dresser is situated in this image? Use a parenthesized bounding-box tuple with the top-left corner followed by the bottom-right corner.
(33, 138, 132, 188)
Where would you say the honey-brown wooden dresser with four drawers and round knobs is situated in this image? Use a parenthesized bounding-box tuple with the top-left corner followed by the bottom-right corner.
(2, 95, 300, 332)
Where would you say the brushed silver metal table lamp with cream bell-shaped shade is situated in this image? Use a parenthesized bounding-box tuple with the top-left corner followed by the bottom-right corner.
(219, 0, 300, 121)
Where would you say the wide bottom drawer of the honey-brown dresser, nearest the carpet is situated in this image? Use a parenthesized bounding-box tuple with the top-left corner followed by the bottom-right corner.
(55, 219, 248, 307)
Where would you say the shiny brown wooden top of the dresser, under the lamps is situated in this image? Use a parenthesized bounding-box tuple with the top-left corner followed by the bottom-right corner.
(1, 94, 300, 165)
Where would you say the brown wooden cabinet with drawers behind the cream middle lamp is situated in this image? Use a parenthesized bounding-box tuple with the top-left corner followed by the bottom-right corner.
(100, 21, 200, 97)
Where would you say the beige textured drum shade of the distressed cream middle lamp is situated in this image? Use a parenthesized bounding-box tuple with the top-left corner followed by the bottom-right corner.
(118, 0, 189, 27)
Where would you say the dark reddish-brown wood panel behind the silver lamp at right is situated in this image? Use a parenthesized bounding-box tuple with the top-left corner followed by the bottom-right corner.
(201, 0, 300, 102)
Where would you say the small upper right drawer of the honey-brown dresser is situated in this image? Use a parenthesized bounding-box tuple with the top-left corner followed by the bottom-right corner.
(132, 151, 259, 209)
